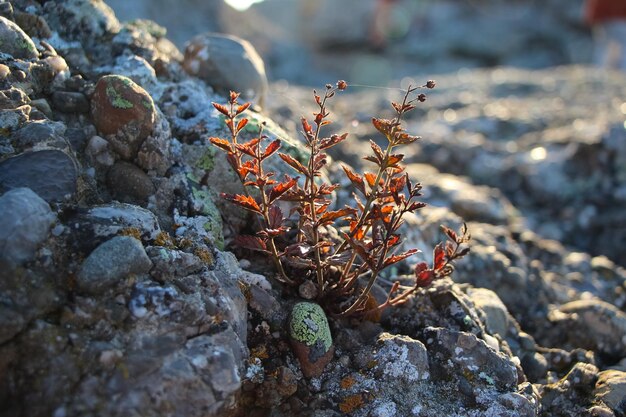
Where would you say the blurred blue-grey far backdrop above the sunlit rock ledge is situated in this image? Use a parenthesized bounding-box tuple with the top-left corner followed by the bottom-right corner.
(108, 0, 592, 86)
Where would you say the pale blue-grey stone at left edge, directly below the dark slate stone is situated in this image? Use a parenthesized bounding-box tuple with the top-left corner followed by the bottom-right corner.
(0, 188, 56, 264)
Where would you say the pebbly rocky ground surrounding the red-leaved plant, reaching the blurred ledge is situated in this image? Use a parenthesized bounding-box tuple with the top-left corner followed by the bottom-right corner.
(0, 0, 626, 417)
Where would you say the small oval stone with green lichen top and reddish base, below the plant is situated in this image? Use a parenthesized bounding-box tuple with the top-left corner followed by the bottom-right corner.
(289, 302, 334, 378)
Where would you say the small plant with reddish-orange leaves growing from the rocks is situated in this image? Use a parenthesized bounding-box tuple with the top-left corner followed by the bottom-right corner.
(210, 81, 469, 316)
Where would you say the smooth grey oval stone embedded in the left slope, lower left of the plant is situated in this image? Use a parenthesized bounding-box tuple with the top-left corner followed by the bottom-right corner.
(76, 236, 152, 294)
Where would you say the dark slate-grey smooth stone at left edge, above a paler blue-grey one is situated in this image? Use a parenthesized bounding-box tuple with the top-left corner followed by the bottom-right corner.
(0, 150, 78, 202)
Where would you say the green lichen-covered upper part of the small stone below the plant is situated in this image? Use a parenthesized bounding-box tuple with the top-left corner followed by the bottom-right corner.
(289, 302, 333, 351)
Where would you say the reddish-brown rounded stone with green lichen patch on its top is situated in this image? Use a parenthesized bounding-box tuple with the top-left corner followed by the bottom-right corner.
(91, 75, 156, 159)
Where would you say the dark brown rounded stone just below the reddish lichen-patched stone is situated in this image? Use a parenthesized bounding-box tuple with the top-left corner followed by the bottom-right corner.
(107, 161, 156, 203)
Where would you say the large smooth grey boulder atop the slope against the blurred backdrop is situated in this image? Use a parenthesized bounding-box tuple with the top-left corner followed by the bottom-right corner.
(183, 33, 268, 105)
